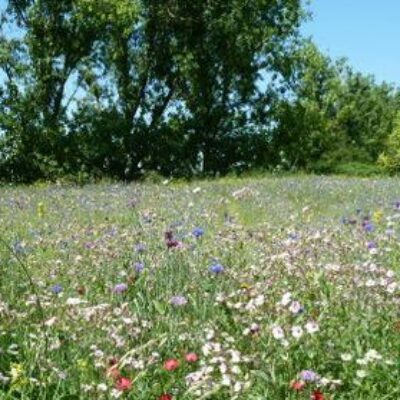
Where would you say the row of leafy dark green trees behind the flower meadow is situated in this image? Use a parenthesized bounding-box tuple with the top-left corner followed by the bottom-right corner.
(0, 0, 400, 182)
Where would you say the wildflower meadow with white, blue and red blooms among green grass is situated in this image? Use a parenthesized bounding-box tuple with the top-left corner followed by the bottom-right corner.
(0, 176, 400, 400)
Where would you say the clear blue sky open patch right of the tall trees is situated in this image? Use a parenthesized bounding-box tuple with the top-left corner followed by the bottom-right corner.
(303, 0, 400, 85)
